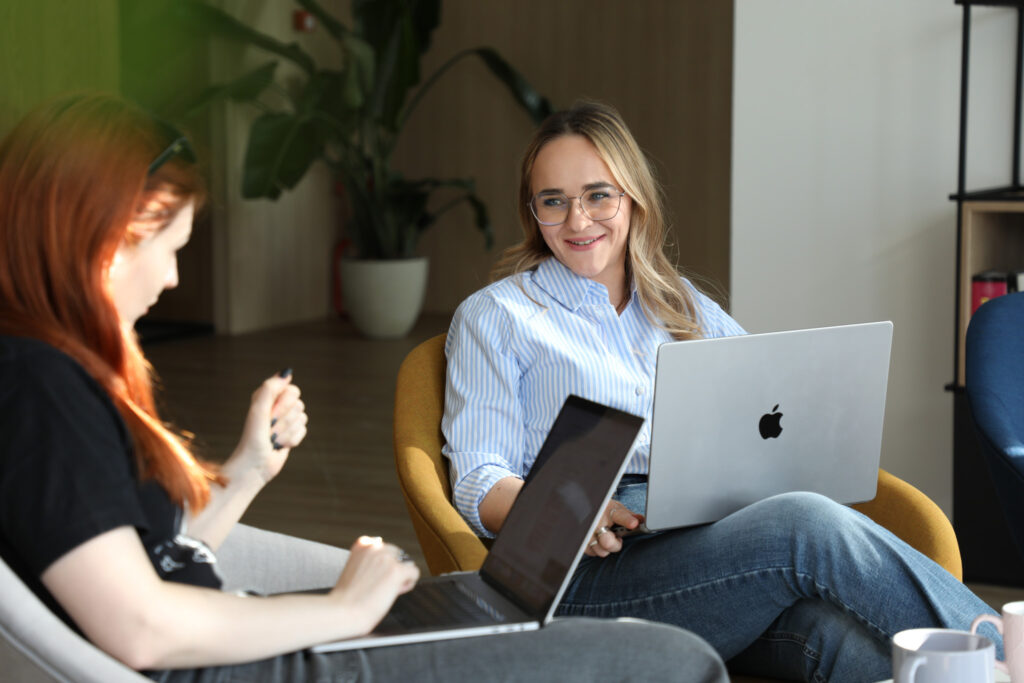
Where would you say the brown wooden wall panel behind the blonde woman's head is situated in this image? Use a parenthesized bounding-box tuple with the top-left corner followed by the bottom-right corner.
(396, 0, 732, 312)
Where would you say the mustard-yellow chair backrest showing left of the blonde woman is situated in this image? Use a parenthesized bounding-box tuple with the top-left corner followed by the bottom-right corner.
(394, 335, 487, 575)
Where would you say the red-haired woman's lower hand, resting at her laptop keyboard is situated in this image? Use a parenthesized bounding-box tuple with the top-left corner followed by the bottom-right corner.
(331, 536, 420, 633)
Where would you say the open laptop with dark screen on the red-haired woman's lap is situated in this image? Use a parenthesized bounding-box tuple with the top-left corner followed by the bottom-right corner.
(313, 396, 644, 652)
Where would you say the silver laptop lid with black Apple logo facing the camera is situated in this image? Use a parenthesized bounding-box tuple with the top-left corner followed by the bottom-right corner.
(646, 322, 893, 529)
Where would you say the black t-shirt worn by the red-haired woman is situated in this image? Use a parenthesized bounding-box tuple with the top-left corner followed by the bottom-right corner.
(0, 336, 221, 627)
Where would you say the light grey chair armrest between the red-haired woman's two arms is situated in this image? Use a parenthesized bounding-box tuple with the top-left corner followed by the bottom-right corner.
(217, 524, 348, 595)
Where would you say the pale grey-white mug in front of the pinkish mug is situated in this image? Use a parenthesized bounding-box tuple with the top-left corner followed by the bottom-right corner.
(893, 629, 995, 683)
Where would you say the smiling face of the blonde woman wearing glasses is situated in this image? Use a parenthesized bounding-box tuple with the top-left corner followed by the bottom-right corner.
(530, 135, 633, 305)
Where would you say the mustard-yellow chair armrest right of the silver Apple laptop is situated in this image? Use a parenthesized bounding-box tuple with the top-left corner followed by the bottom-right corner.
(851, 469, 964, 581)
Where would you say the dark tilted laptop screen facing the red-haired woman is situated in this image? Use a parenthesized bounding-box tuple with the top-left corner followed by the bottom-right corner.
(480, 396, 643, 618)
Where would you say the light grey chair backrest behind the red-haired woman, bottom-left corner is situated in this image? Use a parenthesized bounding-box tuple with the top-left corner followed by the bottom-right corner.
(0, 560, 150, 683)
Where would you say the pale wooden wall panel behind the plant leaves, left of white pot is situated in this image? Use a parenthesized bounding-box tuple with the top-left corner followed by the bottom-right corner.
(211, 0, 339, 333)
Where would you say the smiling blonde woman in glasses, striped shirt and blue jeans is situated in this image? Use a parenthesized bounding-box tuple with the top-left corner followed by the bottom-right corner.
(441, 98, 989, 681)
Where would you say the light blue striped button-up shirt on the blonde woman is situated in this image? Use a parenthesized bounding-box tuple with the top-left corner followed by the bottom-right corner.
(441, 258, 745, 537)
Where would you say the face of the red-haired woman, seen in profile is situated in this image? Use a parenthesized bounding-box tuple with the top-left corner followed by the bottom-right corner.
(108, 193, 196, 326)
